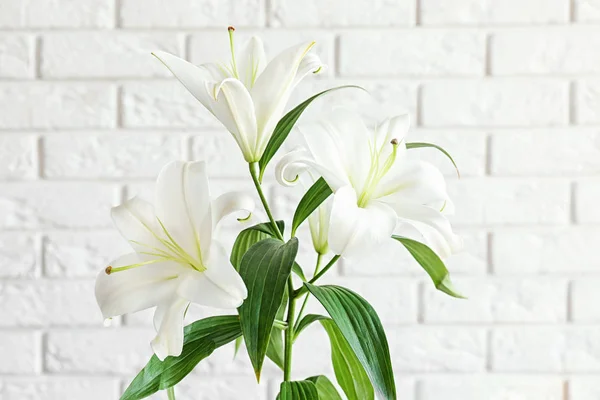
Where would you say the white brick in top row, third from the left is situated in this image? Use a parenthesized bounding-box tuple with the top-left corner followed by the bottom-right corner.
(269, 0, 416, 28)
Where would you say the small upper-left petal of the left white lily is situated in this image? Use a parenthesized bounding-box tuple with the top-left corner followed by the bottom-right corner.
(110, 197, 162, 252)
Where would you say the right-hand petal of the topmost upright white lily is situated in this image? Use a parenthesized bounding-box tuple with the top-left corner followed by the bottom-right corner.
(251, 42, 320, 158)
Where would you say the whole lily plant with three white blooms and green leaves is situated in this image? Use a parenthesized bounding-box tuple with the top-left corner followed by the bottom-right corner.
(96, 27, 461, 400)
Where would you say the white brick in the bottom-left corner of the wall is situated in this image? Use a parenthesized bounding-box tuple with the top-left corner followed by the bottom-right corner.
(0, 376, 117, 400)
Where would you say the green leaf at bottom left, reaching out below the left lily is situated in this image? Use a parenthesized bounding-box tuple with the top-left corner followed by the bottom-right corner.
(121, 315, 242, 400)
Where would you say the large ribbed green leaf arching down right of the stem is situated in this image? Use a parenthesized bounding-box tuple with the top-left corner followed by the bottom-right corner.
(304, 283, 396, 400)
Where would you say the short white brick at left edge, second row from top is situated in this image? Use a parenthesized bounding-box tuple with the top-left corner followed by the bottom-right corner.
(0, 34, 35, 78)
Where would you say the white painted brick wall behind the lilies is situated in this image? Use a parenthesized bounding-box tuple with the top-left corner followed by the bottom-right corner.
(0, 0, 600, 400)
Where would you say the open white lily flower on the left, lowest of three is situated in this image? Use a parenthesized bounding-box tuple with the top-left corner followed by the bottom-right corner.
(96, 162, 254, 360)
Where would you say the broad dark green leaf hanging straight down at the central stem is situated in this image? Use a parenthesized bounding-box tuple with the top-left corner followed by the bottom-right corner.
(238, 238, 298, 380)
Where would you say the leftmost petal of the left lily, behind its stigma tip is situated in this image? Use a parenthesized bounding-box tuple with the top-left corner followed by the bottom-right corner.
(96, 253, 186, 318)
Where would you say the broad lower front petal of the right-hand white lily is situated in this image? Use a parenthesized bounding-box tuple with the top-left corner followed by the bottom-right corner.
(329, 186, 397, 258)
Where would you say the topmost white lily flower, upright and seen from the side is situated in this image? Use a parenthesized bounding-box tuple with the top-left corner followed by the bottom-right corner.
(152, 27, 324, 162)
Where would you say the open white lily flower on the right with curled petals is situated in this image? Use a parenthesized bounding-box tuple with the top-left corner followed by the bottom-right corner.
(276, 109, 461, 258)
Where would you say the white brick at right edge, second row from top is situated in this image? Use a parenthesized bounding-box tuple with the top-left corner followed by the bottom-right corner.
(490, 27, 600, 75)
